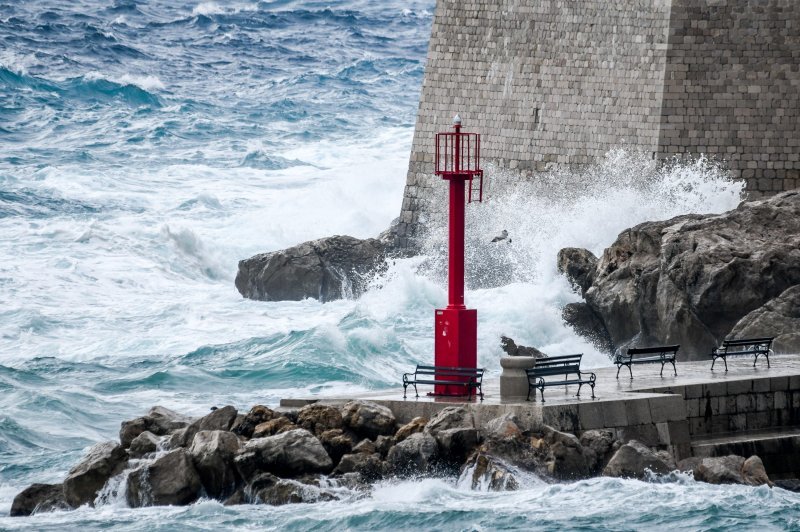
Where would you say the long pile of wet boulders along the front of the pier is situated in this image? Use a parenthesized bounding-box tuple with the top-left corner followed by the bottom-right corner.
(11, 401, 771, 516)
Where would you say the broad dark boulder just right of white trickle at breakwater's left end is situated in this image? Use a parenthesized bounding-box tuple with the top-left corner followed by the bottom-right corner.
(126, 449, 203, 508)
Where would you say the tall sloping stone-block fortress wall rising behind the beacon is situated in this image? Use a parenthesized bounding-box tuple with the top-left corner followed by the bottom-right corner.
(395, 0, 800, 245)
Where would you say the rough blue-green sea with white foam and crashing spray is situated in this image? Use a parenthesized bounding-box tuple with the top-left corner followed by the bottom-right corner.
(0, 0, 800, 531)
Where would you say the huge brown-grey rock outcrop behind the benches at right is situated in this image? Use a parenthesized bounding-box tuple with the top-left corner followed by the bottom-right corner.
(558, 191, 800, 360)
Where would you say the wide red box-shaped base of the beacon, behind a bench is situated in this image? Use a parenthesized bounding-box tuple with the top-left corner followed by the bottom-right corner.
(434, 309, 478, 395)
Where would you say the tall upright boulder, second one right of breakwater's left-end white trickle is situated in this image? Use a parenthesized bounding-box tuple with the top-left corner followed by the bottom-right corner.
(189, 430, 240, 499)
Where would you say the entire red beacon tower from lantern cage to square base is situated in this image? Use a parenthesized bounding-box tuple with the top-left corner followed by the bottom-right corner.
(434, 115, 483, 395)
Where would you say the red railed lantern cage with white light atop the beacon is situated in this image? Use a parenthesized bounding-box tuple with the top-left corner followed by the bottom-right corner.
(435, 115, 483, 203)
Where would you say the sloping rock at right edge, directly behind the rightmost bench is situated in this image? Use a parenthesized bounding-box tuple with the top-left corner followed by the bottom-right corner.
(728, 285, 800, 353)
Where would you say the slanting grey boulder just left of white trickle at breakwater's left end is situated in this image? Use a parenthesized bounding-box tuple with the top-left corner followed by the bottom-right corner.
(64, 441, 128, 508)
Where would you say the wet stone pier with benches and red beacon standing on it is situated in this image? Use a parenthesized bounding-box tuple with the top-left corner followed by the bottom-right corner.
(281, 355, 800, 478)
